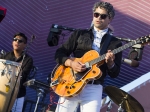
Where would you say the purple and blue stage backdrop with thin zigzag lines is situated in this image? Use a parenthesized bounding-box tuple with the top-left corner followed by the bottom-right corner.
(0, 0, 150, 111)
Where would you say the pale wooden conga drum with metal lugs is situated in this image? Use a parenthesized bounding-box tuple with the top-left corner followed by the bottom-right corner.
(0, 59, 20, 112)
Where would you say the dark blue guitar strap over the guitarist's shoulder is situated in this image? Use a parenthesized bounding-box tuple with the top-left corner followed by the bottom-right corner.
(100, 33, 112, 55)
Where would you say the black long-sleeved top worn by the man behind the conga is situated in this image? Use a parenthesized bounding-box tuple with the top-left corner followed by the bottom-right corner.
(0, 51, 33, 98)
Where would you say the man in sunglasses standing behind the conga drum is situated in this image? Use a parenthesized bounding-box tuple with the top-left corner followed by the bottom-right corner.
(0, 33, 33, 112)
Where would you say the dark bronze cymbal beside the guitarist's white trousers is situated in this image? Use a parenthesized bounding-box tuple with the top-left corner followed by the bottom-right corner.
(104, 86, 144, 112)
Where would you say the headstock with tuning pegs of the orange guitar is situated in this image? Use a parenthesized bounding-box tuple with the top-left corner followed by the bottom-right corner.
(136, 35, 150, 46)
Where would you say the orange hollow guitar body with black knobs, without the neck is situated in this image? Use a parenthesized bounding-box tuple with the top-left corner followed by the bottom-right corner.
(50, 50, 104, 97)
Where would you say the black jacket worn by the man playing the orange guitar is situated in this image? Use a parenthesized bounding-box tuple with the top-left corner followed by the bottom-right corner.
(55, 29, 122, 84)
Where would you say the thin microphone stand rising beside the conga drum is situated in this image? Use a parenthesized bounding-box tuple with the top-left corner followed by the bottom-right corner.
(6, 35, 35, 112)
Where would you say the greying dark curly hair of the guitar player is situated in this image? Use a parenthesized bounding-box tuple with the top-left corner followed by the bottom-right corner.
(93, 1, 115, 18)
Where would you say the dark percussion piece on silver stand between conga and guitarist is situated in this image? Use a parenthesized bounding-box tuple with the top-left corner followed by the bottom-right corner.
(23, 79, 50, 112)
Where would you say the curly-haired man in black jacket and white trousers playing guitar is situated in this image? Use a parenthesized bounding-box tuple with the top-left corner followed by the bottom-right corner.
(55, 1, 122, 112)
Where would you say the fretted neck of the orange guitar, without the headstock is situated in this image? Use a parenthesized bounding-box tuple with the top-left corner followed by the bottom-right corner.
(89, 40, 138, 66)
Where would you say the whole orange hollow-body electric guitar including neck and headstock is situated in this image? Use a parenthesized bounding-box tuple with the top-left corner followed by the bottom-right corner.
(50, 36, 150, 97)
